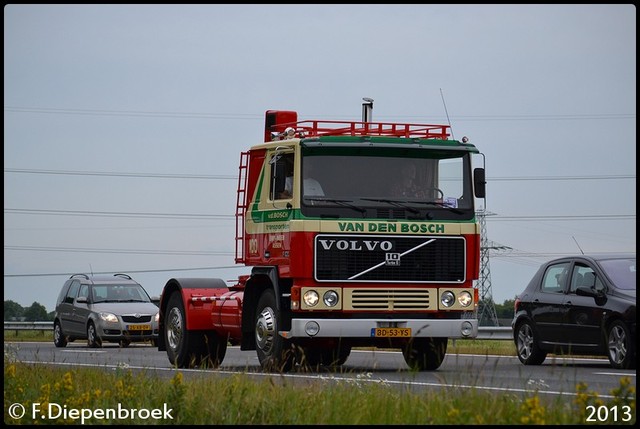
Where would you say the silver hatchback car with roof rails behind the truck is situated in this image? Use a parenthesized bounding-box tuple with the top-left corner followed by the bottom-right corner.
(53, 274, 159, 347)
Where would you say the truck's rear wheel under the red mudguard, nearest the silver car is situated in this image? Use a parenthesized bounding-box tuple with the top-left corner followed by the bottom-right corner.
(163, 291, 227, 368)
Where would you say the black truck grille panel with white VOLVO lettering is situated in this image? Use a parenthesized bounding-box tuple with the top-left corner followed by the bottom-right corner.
(315, 235, 465, 283)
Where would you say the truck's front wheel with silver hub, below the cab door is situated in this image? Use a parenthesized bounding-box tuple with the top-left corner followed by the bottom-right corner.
(255, 289, 295, 372)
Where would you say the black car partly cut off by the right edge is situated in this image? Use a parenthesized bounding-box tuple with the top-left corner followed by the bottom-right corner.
(511, 253, 636, 369)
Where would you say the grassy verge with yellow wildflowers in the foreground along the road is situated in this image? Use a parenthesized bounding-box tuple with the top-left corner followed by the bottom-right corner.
(4, 355, 636, 425)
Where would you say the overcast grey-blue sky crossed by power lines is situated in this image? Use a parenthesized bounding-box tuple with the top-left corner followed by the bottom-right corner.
(4, 4, 636, 311)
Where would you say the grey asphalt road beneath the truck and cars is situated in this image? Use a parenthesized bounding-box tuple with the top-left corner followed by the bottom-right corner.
(4, 341, 636, 400)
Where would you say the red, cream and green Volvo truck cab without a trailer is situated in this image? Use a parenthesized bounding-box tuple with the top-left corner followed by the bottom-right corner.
(158, 102, 485, 371)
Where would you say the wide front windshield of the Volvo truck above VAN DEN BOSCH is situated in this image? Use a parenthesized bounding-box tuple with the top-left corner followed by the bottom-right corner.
(302, 151, 473, 213)
